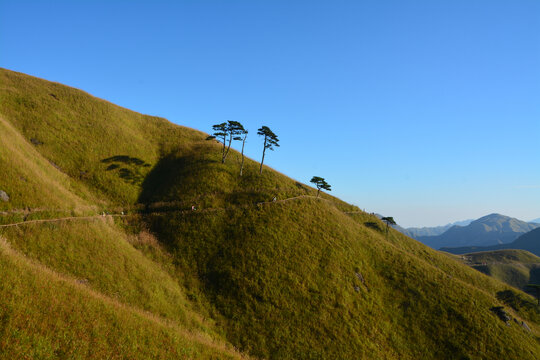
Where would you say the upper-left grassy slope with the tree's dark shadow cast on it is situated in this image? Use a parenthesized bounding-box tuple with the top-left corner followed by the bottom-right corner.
(0, 69, 203, 204)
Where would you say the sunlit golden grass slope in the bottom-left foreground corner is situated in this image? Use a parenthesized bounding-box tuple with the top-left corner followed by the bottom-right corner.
(0, 238, 245, 359)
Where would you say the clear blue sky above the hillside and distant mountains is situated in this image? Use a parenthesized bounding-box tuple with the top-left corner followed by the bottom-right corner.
(0, 0, 540, 226)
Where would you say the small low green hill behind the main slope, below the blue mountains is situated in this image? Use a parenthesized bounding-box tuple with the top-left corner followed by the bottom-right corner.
(450, 250, 540, 291)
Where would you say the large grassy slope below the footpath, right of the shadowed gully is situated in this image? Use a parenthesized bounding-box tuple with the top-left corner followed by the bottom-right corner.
(144, 195, 540, 359)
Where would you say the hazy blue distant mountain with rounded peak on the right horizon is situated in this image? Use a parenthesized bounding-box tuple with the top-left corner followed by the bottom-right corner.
(417, 214, 540, 249)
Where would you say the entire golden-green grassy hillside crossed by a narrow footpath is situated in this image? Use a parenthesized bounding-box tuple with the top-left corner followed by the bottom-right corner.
(0, 70, 540, 359)
